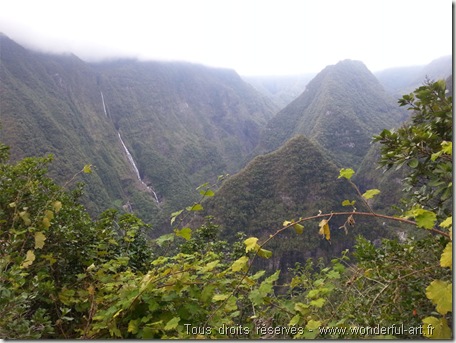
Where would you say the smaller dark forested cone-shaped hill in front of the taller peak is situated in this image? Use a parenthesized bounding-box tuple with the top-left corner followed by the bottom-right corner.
(204, 135, 394, 270)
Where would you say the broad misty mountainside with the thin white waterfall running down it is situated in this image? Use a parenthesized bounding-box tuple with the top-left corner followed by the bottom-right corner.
(0, 35, 277, 228)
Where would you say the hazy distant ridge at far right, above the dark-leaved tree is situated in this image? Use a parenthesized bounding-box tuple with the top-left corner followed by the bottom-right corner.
(375, 56, 453, 98)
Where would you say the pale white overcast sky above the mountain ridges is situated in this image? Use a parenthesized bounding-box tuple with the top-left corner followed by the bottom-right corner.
(0, 0, 453, 75)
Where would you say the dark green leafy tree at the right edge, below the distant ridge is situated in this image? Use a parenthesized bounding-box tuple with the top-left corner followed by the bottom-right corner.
(374, 80, 453, 218)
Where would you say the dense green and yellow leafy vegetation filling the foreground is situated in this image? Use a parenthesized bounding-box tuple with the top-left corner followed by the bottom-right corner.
(0, 82, 453, 339)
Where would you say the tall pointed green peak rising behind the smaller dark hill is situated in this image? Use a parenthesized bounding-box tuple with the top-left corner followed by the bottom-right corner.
(255, 60, 407, 167)
